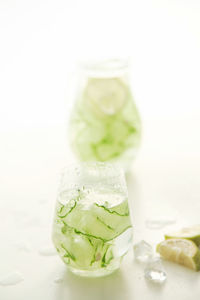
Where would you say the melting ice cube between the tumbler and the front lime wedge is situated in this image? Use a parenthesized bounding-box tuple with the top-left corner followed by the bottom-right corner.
(133, 240, 153, 263)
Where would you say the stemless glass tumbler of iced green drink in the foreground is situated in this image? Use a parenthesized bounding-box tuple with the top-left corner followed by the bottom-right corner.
(53, 162, 132, 277)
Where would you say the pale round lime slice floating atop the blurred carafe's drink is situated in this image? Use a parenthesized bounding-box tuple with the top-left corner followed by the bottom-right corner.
(84, 78, 128, 116)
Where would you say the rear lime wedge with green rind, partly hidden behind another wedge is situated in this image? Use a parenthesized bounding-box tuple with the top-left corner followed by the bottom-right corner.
(165, 225, 200, 246)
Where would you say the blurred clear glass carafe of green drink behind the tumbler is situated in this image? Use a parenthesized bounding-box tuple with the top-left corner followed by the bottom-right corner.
(69, 60, 141, 170)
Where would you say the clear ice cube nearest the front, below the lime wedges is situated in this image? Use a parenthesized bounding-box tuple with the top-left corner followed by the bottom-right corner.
(144, 258, 167, 284)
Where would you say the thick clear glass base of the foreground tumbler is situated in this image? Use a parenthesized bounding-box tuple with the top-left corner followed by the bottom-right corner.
(68, 265, 119, 278)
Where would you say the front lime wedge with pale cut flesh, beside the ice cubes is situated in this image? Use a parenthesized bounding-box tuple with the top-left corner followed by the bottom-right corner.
(156, 239, 200, 271)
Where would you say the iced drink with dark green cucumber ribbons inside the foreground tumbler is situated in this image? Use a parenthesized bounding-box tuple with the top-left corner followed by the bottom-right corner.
(53, 190, 132, 270)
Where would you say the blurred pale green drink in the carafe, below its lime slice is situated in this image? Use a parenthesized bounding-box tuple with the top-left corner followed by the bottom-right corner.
(71, 83, 141, 165)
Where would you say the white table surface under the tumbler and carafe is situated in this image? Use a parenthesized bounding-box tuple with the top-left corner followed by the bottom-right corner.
(0, 120, 200, 300)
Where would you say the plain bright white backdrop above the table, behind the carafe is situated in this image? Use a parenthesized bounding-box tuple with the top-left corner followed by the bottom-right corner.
(0, 0, 200, 128)
